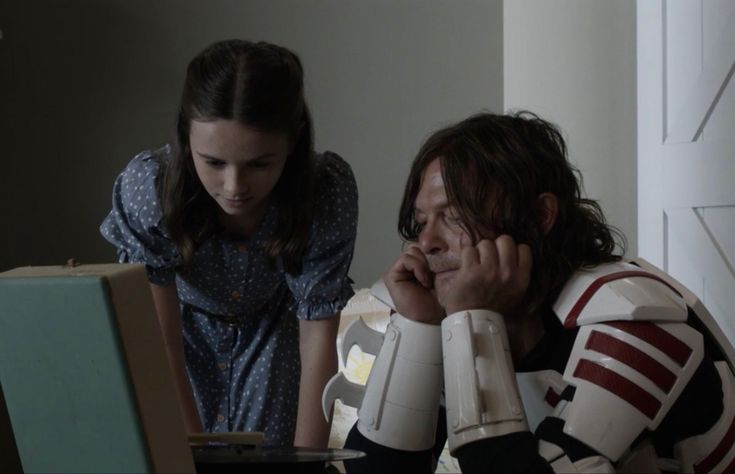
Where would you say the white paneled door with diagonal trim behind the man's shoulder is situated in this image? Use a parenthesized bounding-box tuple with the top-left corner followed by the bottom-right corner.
(637, 0, 735, 343)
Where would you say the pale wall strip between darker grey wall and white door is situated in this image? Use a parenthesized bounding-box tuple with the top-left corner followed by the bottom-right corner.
(503, 0, 637, 256)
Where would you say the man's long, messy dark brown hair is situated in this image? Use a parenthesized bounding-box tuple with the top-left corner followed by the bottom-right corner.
(398, 111, 626, 311)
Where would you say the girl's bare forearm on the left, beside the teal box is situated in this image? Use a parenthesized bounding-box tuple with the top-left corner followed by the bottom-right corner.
(151, 284, 203, 433)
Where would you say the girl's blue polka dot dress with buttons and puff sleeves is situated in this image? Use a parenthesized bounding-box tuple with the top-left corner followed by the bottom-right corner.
(100, 146, 357, 446)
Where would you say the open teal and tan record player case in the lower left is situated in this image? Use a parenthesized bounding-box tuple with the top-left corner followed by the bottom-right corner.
(0, 264, 190, 473)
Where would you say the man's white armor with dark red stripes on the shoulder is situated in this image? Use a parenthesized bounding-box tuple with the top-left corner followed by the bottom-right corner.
(324, 261, 735, 472)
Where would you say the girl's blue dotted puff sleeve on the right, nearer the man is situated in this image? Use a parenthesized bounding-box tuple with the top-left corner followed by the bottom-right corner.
(286, 152, 358, 320)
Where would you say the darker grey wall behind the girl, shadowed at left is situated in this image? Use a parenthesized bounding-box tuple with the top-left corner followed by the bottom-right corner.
(0, 0, 503, 286)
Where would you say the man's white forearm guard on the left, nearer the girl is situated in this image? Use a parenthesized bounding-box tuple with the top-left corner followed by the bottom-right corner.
(357, 313, 442, 451)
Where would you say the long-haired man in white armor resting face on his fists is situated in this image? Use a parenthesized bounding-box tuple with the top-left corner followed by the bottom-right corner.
(325, 112, 735, 472)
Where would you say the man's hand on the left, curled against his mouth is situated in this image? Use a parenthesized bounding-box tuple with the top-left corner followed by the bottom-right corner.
(383, 245, 445, 324)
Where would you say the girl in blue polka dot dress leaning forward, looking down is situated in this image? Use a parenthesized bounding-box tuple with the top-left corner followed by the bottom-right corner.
(100, 40, 357, 448)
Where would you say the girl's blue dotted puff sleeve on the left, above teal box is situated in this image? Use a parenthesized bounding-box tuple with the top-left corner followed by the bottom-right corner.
(100, 147, 181, 285)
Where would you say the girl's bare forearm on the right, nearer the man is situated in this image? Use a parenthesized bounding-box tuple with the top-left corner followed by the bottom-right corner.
(294, 315, 339, 448)
